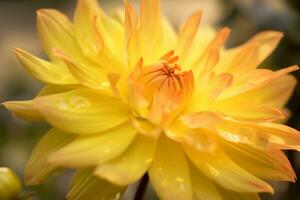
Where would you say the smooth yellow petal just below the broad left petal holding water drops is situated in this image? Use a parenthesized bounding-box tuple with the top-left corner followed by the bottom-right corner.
(49, 123, 136, 167)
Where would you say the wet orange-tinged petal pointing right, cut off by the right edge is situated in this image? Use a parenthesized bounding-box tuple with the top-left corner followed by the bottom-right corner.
(216, 119, 300, 150)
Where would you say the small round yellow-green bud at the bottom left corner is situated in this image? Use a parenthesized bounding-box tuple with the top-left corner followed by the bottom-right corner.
(0, 167, 21, 200)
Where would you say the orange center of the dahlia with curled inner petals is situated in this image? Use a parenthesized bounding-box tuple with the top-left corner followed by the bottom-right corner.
(130, 51, 194, 124)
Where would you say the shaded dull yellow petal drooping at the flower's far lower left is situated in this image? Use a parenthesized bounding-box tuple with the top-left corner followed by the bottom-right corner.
(25, 129, 75, 185)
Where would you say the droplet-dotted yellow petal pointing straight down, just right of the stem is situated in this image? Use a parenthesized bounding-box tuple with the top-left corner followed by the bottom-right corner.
(148, 137, 192, 200)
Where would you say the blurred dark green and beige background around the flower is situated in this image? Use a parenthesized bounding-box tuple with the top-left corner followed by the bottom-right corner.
(0, 0, 300, 200)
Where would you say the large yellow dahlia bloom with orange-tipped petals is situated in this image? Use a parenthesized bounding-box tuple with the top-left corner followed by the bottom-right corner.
(4, 0, 300, 200)
